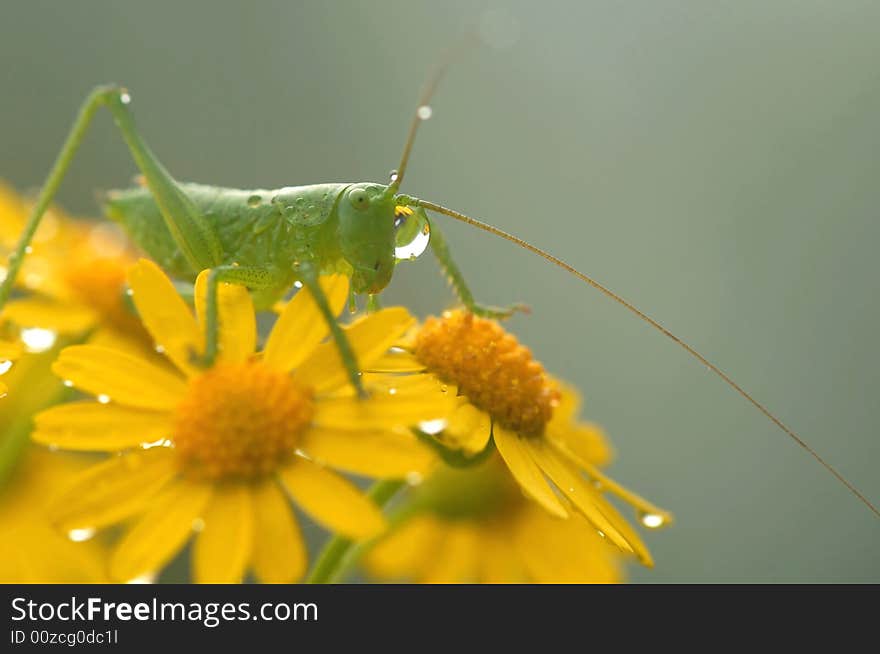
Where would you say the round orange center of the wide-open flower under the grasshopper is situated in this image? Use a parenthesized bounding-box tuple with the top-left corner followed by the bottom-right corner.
(172, 362, 314, 480)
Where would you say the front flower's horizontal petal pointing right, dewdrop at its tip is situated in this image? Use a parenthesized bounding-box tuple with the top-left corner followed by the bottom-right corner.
(313, 393, 452, 429)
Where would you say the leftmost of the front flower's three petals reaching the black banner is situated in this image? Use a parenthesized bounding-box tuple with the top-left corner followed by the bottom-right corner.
(110, 479, 212, 581)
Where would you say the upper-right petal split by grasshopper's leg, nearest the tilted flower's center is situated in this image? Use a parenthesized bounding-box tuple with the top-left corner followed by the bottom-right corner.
(294, 307, 415, 392)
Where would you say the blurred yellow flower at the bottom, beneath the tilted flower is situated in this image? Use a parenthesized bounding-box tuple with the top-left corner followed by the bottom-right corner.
(364, 456, 623, 583)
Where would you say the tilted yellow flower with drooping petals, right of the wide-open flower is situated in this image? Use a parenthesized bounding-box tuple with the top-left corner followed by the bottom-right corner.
(388, 311, 672, 566)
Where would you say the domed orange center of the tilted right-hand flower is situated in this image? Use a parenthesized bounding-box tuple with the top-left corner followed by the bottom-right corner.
(415, 311, 559, 435)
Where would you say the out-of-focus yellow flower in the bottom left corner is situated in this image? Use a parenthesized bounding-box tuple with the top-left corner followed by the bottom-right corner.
(0, 352, 107, 583)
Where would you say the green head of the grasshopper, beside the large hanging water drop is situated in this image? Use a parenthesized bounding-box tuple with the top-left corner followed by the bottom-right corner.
(338, 184, 395, 293)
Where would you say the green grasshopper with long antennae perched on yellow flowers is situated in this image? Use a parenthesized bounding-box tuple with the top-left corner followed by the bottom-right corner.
(0, 68, 880, 517)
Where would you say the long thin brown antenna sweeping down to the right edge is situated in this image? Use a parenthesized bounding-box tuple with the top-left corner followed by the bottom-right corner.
(408, 198, 880, 518)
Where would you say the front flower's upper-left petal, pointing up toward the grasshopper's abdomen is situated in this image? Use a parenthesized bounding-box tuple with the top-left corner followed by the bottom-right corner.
(128, 259, 205, 375)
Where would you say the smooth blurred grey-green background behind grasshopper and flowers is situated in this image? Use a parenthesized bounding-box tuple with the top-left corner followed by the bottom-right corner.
(0, 0, 880, 582)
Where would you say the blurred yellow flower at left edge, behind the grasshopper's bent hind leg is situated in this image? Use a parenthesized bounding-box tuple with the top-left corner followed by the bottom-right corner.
(0, 184, 146, 351)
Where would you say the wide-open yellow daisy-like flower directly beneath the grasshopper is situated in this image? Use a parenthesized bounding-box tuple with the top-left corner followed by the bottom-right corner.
(34, 261, 448, 582)
